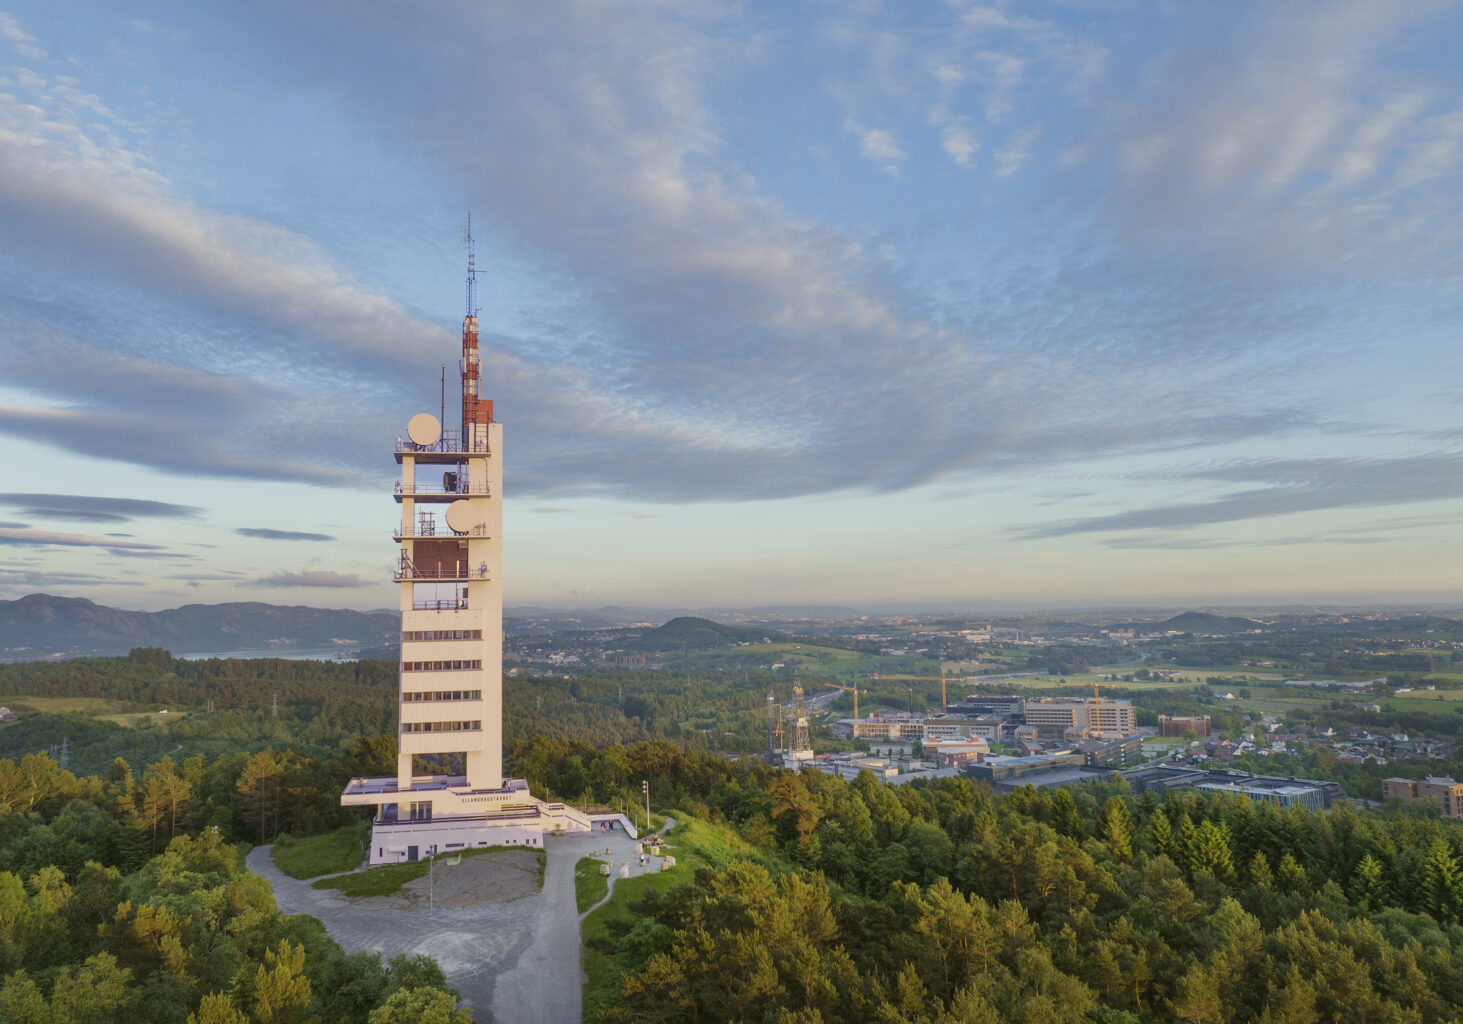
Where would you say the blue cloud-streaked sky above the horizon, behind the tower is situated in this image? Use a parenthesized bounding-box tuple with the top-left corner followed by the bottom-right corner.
(0, 0, 1463, 610)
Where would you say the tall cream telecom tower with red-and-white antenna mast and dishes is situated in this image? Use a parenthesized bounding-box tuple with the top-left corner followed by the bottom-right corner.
(341, 233, 602, 865)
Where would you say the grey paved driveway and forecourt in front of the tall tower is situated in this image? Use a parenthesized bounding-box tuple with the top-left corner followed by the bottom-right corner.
(247, 819, 674, 1024)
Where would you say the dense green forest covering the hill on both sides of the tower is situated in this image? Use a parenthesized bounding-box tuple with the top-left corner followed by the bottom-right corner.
(0, 652, 1463, 1024)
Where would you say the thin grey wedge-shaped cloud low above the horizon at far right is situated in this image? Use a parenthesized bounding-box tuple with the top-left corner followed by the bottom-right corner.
(1015, 452, 1463, 546)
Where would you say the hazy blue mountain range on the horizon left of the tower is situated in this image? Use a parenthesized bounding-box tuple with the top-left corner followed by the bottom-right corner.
(0, 594, 401, 661)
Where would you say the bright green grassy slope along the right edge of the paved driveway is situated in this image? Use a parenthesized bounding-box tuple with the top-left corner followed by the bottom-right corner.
(581, 810, 755, 1021)
